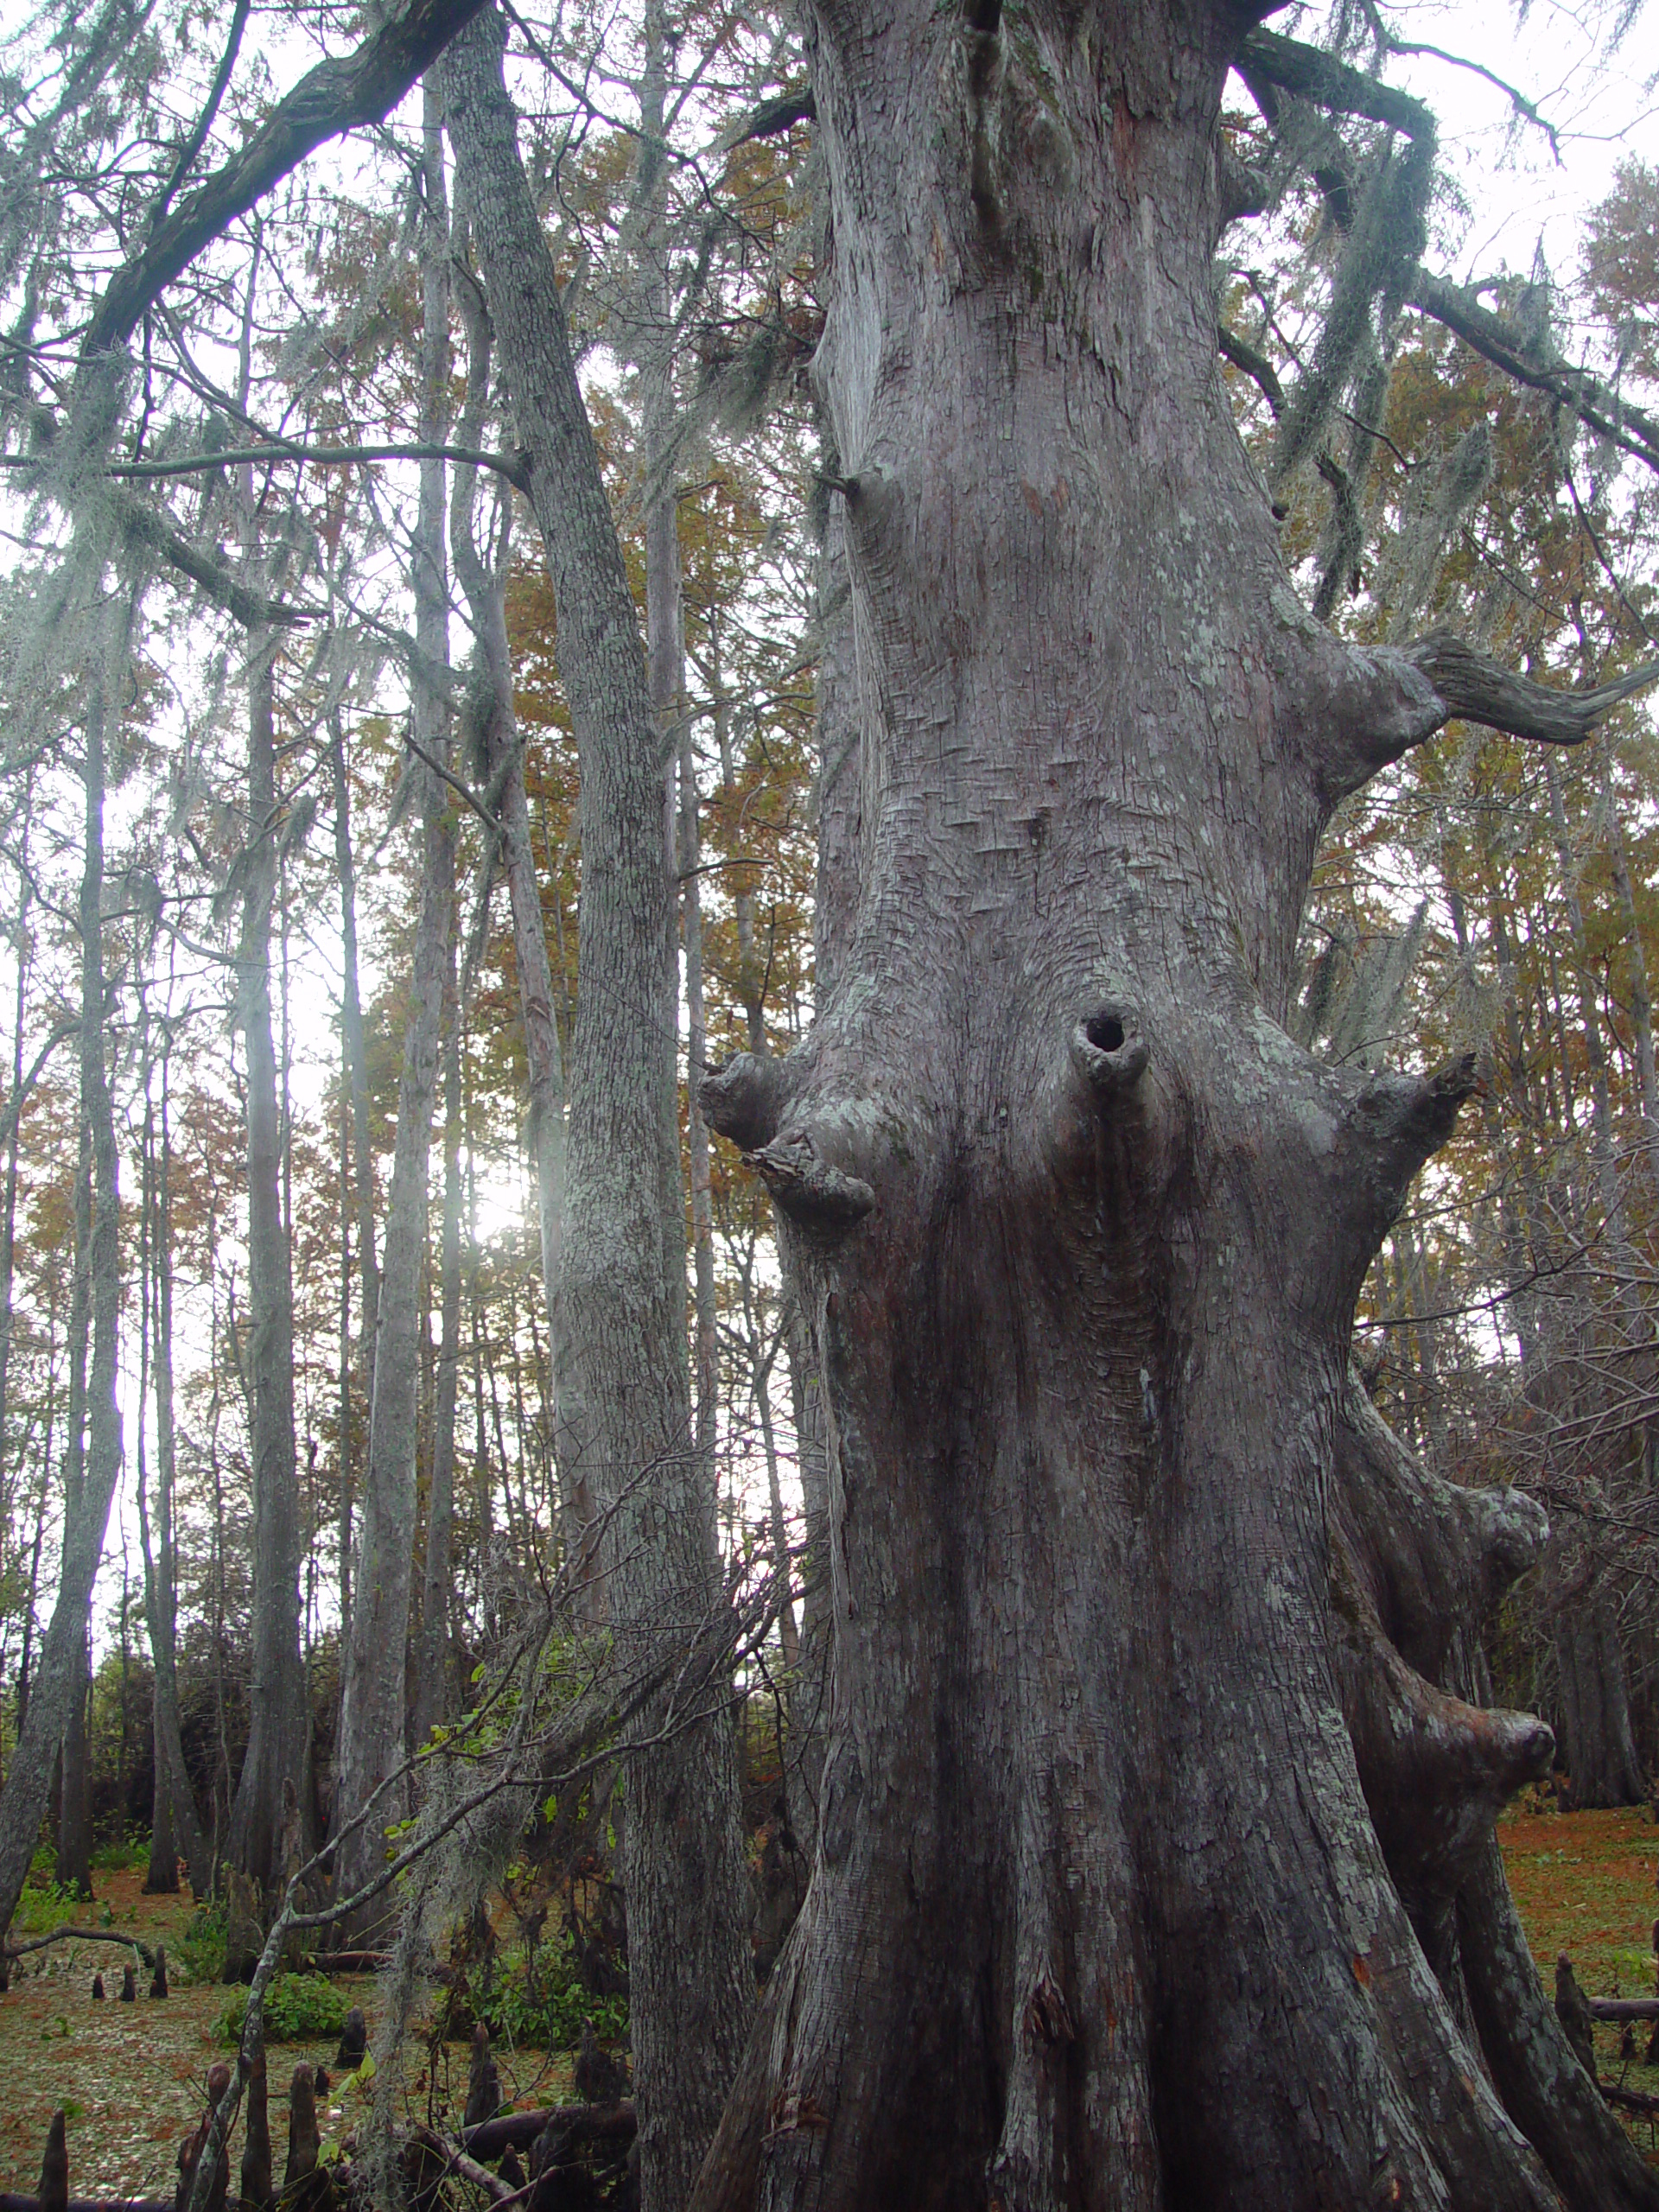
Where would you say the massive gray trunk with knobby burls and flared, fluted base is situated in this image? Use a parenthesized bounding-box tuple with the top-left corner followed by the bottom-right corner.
(695, 0, 1659, 2212)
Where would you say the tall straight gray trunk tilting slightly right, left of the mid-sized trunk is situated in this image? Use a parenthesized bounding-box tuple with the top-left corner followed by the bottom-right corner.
(334, 79, 455, 1896)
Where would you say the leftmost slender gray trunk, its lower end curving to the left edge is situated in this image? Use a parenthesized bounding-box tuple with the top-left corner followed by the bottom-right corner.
(0, 632, 126, 1936)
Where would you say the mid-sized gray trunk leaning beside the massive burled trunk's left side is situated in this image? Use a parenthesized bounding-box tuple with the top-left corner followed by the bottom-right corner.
(442, 11, 752, 2212)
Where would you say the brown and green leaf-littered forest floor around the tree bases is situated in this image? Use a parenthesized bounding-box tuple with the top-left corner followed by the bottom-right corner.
(0, 1812, 1659, 2196)
